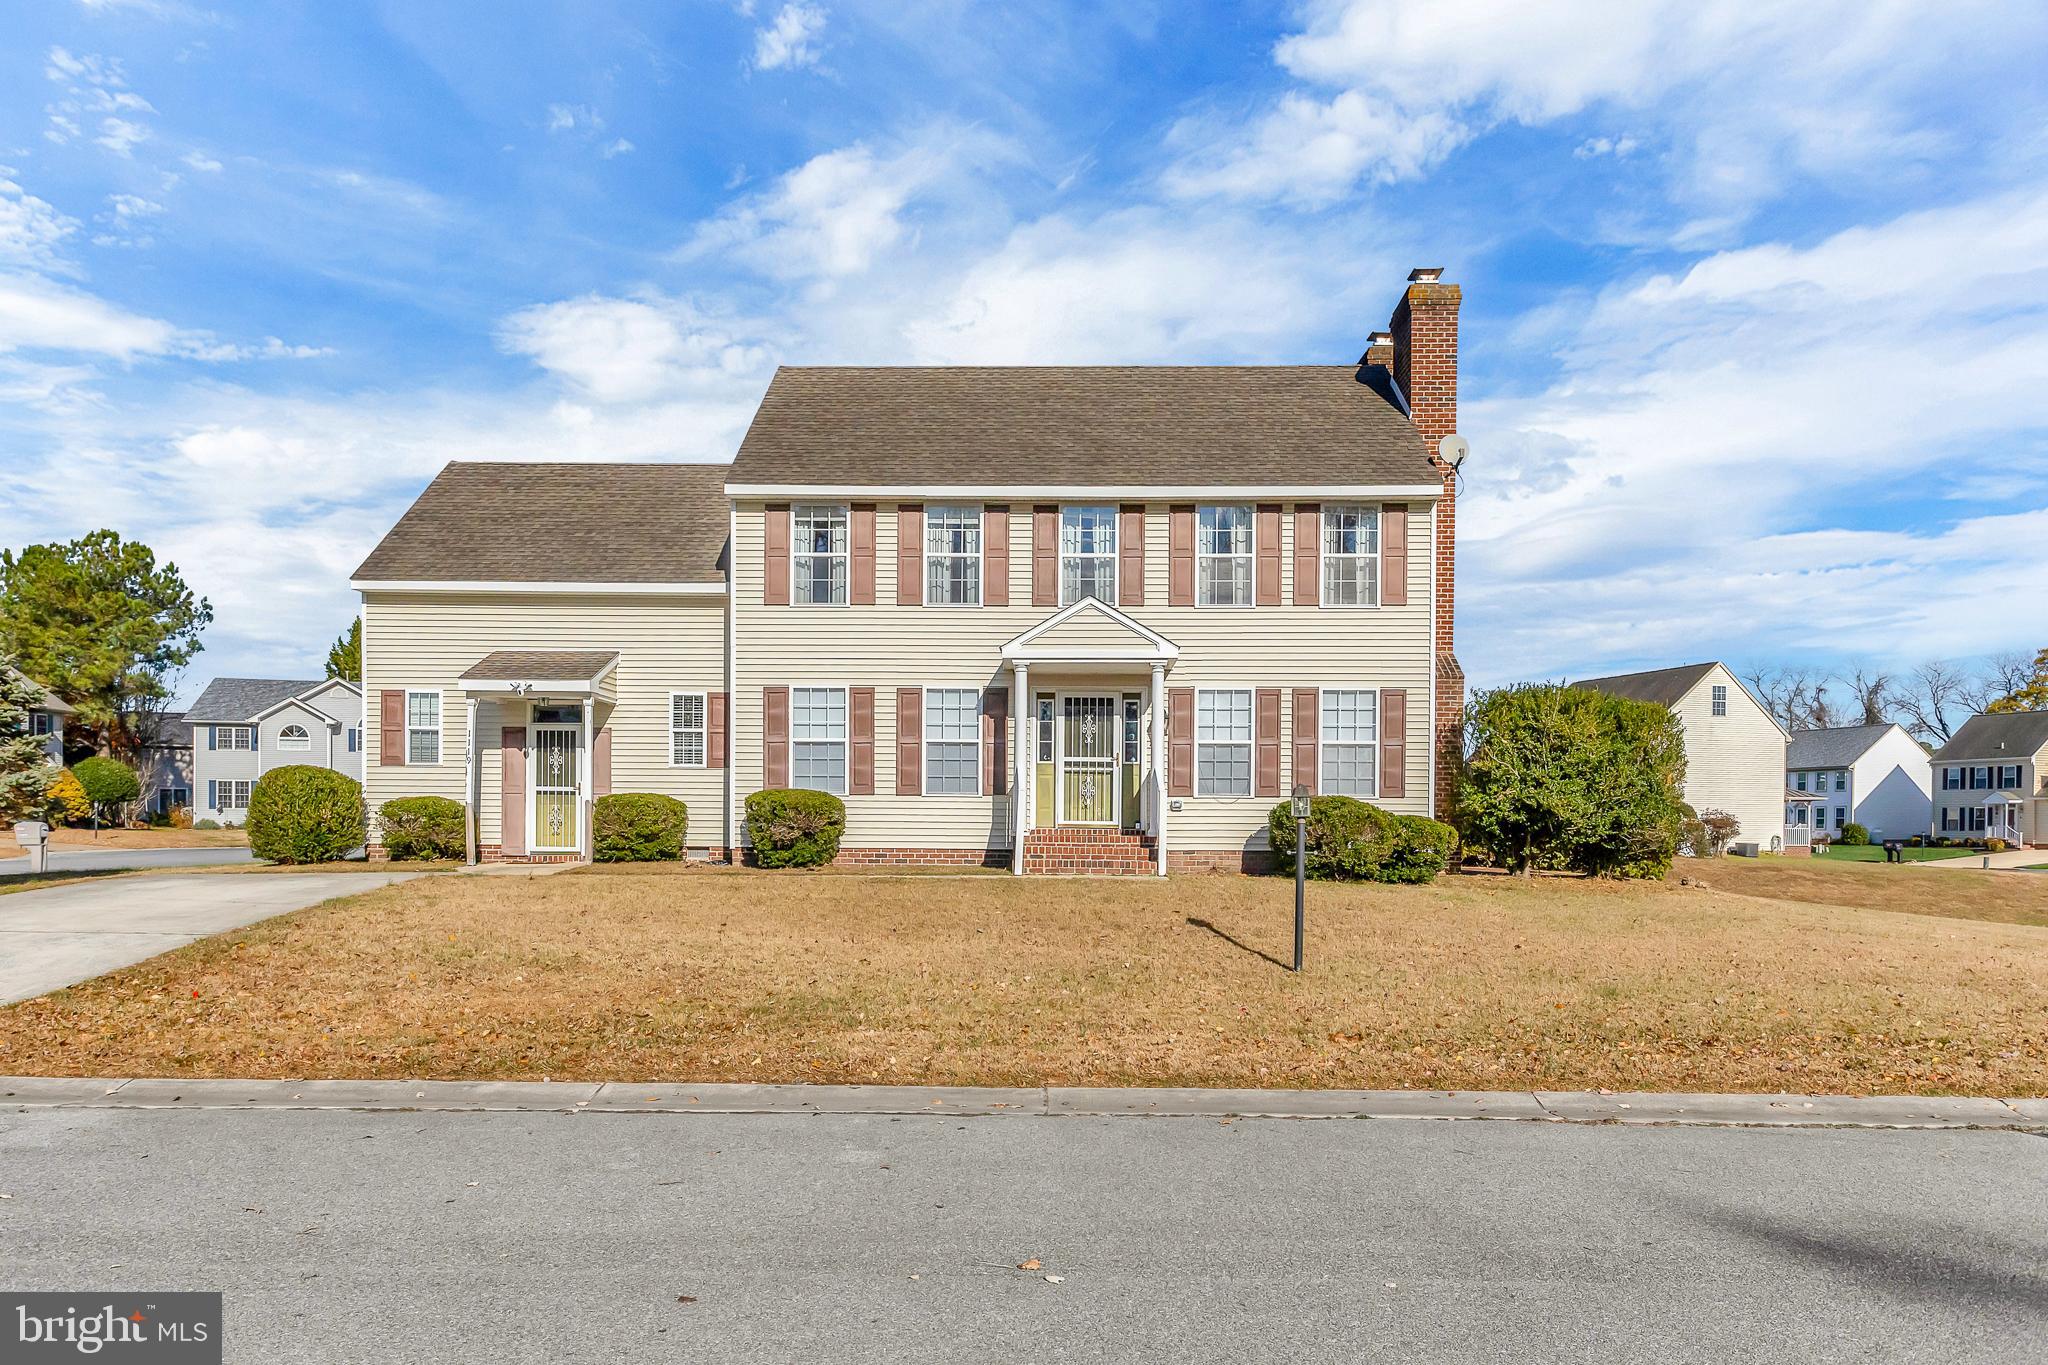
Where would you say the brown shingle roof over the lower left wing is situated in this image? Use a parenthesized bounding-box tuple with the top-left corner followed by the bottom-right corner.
(354, 460, 729, 587)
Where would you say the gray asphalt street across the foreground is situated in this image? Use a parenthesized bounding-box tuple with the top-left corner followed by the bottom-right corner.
(0, 1107, 2048, 1361)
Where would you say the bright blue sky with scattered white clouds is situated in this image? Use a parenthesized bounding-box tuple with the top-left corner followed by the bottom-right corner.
(0, 0, 2048, 694)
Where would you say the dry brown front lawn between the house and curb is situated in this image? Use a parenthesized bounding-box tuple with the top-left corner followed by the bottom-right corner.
(0, 860, 2048, 1095)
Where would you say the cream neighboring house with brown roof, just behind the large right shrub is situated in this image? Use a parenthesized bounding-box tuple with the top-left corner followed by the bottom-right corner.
(1573, 663, 1790, 851)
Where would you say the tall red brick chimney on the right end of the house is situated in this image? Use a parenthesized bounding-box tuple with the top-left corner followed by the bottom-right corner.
(1366, 268, 1464, 814)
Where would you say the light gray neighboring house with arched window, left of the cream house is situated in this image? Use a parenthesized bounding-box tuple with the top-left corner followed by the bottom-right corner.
(184, 677, 362, 825)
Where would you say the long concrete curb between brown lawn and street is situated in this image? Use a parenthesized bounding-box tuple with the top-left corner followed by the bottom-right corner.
(0, 1076, 2048, 1132)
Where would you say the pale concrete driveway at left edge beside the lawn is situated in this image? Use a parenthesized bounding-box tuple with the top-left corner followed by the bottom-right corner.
(0, 871, 422, 1005)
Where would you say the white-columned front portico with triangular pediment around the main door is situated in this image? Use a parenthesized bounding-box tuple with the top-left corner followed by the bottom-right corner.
(1001, 598, 1180, 876)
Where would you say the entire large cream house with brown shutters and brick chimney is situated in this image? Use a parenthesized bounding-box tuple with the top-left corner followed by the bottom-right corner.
(354, 270, 1464, 872)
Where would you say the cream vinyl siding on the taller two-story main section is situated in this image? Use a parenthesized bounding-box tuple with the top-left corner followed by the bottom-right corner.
(733, 499, 1434, 851)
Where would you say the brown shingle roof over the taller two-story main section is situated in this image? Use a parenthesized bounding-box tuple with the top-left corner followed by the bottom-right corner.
(729, 364, 1442, 495)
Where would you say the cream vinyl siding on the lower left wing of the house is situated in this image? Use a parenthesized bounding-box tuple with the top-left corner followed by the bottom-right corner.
(362, 593, 729, 847)
